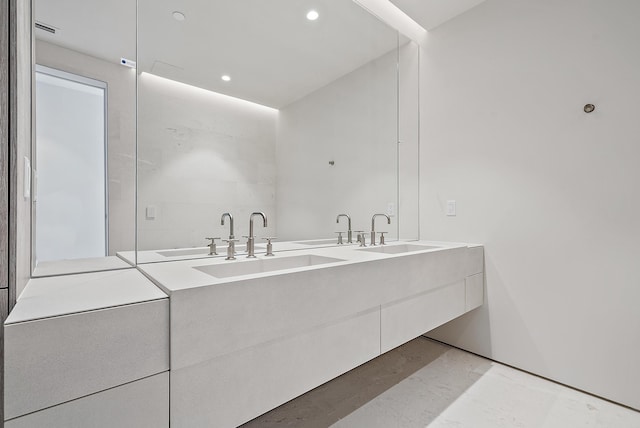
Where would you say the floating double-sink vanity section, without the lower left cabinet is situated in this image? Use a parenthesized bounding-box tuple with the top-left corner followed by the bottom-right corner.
(139, 242, 484, 428)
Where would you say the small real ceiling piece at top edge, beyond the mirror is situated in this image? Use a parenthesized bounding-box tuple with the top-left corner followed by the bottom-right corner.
(390, 0, 486, 31)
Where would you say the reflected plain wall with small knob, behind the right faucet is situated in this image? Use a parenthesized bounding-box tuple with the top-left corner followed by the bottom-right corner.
(277, 51, 398, 242)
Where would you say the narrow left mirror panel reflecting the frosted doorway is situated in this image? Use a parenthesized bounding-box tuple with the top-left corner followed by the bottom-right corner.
(32, 0, 136, 276)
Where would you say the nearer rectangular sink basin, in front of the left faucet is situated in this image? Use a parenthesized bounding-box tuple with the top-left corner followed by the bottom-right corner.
(194, 254, 344, 278)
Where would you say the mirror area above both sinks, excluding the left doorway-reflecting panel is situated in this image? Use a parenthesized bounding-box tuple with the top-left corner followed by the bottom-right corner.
(134, 0, 418, 263)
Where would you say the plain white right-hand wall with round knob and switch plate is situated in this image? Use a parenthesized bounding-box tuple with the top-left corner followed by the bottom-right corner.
(420, 0, 640, 409)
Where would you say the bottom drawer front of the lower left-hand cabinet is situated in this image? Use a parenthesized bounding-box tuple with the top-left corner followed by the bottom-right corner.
(4, 372, 169, 428)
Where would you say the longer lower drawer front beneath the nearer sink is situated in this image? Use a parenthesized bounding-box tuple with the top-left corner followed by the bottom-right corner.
(171, 308, 380, 428)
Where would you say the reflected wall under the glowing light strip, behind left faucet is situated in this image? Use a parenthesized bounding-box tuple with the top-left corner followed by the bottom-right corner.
(138, 73, 278, 250)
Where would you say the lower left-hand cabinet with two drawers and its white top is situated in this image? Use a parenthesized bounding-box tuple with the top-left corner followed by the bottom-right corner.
(4, 269, 169, 428)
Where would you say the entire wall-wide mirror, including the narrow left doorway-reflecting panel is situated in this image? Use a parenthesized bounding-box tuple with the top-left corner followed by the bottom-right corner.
(32, 0, 418, 276)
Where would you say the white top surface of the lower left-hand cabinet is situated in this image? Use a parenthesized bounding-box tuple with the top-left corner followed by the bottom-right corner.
(5, 268, 167, 324)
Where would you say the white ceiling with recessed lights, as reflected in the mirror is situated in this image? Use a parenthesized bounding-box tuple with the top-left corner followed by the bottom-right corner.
(35, 0, 398, 108)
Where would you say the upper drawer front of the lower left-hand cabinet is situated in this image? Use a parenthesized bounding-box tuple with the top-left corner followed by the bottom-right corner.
(4, 299, 169, 419)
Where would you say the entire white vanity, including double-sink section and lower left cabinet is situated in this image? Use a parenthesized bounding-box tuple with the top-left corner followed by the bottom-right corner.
(5, 241, 484, 428)
